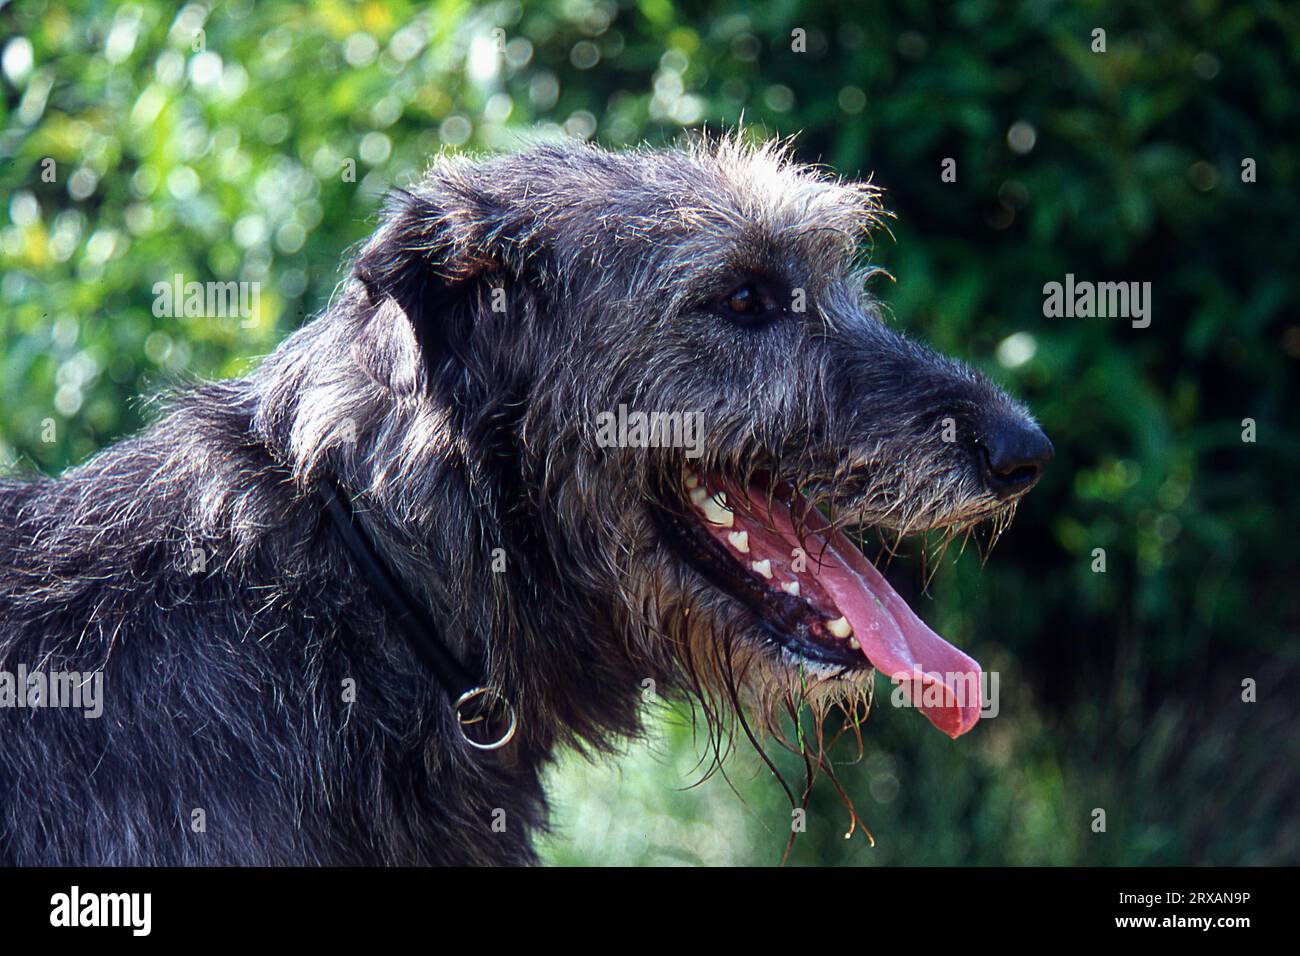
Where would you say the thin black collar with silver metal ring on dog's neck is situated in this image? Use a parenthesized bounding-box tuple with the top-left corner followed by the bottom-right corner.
(317, 479, 517, 750)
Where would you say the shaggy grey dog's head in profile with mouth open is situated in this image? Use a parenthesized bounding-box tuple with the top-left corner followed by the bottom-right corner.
(330, 134, 1052, 736)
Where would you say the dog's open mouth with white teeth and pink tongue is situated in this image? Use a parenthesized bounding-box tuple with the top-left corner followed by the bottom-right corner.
(670, 470, 982, 737)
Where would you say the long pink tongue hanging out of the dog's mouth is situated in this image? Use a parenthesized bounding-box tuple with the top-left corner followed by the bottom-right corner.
(750, 492, 983, 739)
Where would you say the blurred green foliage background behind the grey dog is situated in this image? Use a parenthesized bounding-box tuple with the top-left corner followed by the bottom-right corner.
(0, 0, 1300, 864)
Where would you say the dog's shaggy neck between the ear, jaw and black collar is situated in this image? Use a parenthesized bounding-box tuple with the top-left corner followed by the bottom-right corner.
(252, 316, 655, 760)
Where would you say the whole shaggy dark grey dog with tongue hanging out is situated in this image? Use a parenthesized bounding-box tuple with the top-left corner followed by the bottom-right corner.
(0, 140, 1050, 865)
